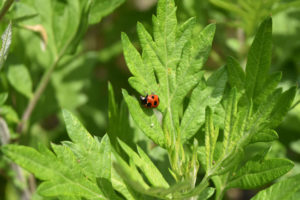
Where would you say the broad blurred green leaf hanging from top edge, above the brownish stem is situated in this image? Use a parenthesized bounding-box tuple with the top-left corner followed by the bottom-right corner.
(35, 0, 91, 56)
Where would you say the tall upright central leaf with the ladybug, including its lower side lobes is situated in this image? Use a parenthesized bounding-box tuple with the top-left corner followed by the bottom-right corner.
(122, 0, 218, 148)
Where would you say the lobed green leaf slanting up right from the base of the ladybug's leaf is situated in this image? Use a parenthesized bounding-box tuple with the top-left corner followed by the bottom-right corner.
(180, 68, 227, 142)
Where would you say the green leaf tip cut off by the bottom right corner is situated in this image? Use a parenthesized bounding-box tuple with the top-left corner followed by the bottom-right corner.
(251, 174, 300, 200)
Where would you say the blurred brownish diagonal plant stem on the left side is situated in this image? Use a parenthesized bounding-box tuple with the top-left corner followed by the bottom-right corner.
(17, 56, 61, 133)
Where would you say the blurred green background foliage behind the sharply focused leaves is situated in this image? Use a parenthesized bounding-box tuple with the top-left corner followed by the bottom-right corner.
(0, 0, 300, 199)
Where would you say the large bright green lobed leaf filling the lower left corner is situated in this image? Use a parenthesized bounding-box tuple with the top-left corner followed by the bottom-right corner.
(2, 111, 112, 199)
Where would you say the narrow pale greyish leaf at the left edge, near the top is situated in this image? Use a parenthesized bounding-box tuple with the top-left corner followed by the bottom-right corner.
(0, 23, 12, 71)
